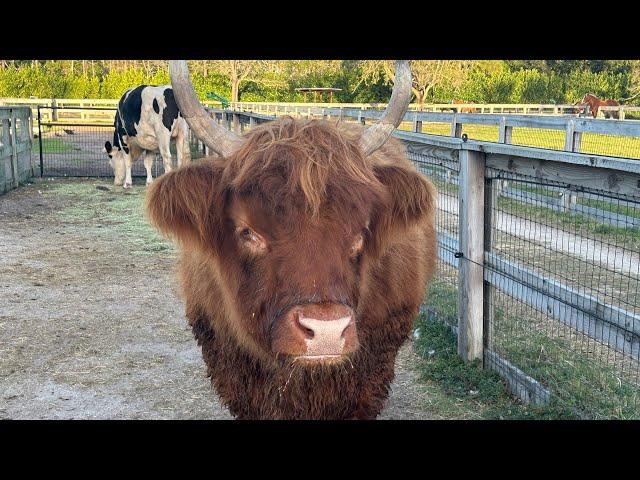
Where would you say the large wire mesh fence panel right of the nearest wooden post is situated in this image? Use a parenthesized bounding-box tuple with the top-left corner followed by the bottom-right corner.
(485, 169, 640, 418)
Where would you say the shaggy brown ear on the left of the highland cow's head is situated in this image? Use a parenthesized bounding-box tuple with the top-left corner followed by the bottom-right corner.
(146, 161, 223, 248)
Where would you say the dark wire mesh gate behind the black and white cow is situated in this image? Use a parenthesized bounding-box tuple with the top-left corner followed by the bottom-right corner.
(34, 107, 204, 177)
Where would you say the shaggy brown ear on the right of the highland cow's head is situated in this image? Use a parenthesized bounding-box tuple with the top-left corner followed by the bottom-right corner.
(369, 164, 437, 253)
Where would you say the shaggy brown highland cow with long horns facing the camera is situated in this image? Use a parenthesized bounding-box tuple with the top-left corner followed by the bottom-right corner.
(147, 62, 437, 419)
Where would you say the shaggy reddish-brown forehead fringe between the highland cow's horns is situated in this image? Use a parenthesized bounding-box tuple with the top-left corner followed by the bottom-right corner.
(223, 117, 386, 216)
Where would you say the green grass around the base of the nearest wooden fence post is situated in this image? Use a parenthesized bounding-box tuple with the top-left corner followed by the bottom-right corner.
(414, 279, 640, 419)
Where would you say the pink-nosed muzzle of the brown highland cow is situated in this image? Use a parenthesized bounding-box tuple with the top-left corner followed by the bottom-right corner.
(272, 303, 358, 363)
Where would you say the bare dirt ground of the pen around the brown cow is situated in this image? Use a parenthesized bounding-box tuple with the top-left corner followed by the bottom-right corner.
(0, 179, 437, 419)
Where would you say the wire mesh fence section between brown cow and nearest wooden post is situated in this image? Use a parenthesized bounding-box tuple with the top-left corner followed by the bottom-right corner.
(409, 147, 459, 327)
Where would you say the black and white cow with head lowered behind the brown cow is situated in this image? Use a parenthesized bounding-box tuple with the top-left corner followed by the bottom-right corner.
(104, 85, 191, 188)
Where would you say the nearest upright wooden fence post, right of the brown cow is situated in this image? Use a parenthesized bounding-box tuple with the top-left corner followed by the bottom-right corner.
(458, 150, 485, 360)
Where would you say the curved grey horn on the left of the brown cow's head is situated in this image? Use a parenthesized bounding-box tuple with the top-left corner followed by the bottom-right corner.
(169, 60, 243, 157)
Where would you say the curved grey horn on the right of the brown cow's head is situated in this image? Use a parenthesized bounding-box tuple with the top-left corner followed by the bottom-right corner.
(360, 60, 413, 156)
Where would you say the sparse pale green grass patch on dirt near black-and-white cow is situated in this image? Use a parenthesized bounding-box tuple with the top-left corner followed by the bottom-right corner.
(43, 181, 173, 255)
